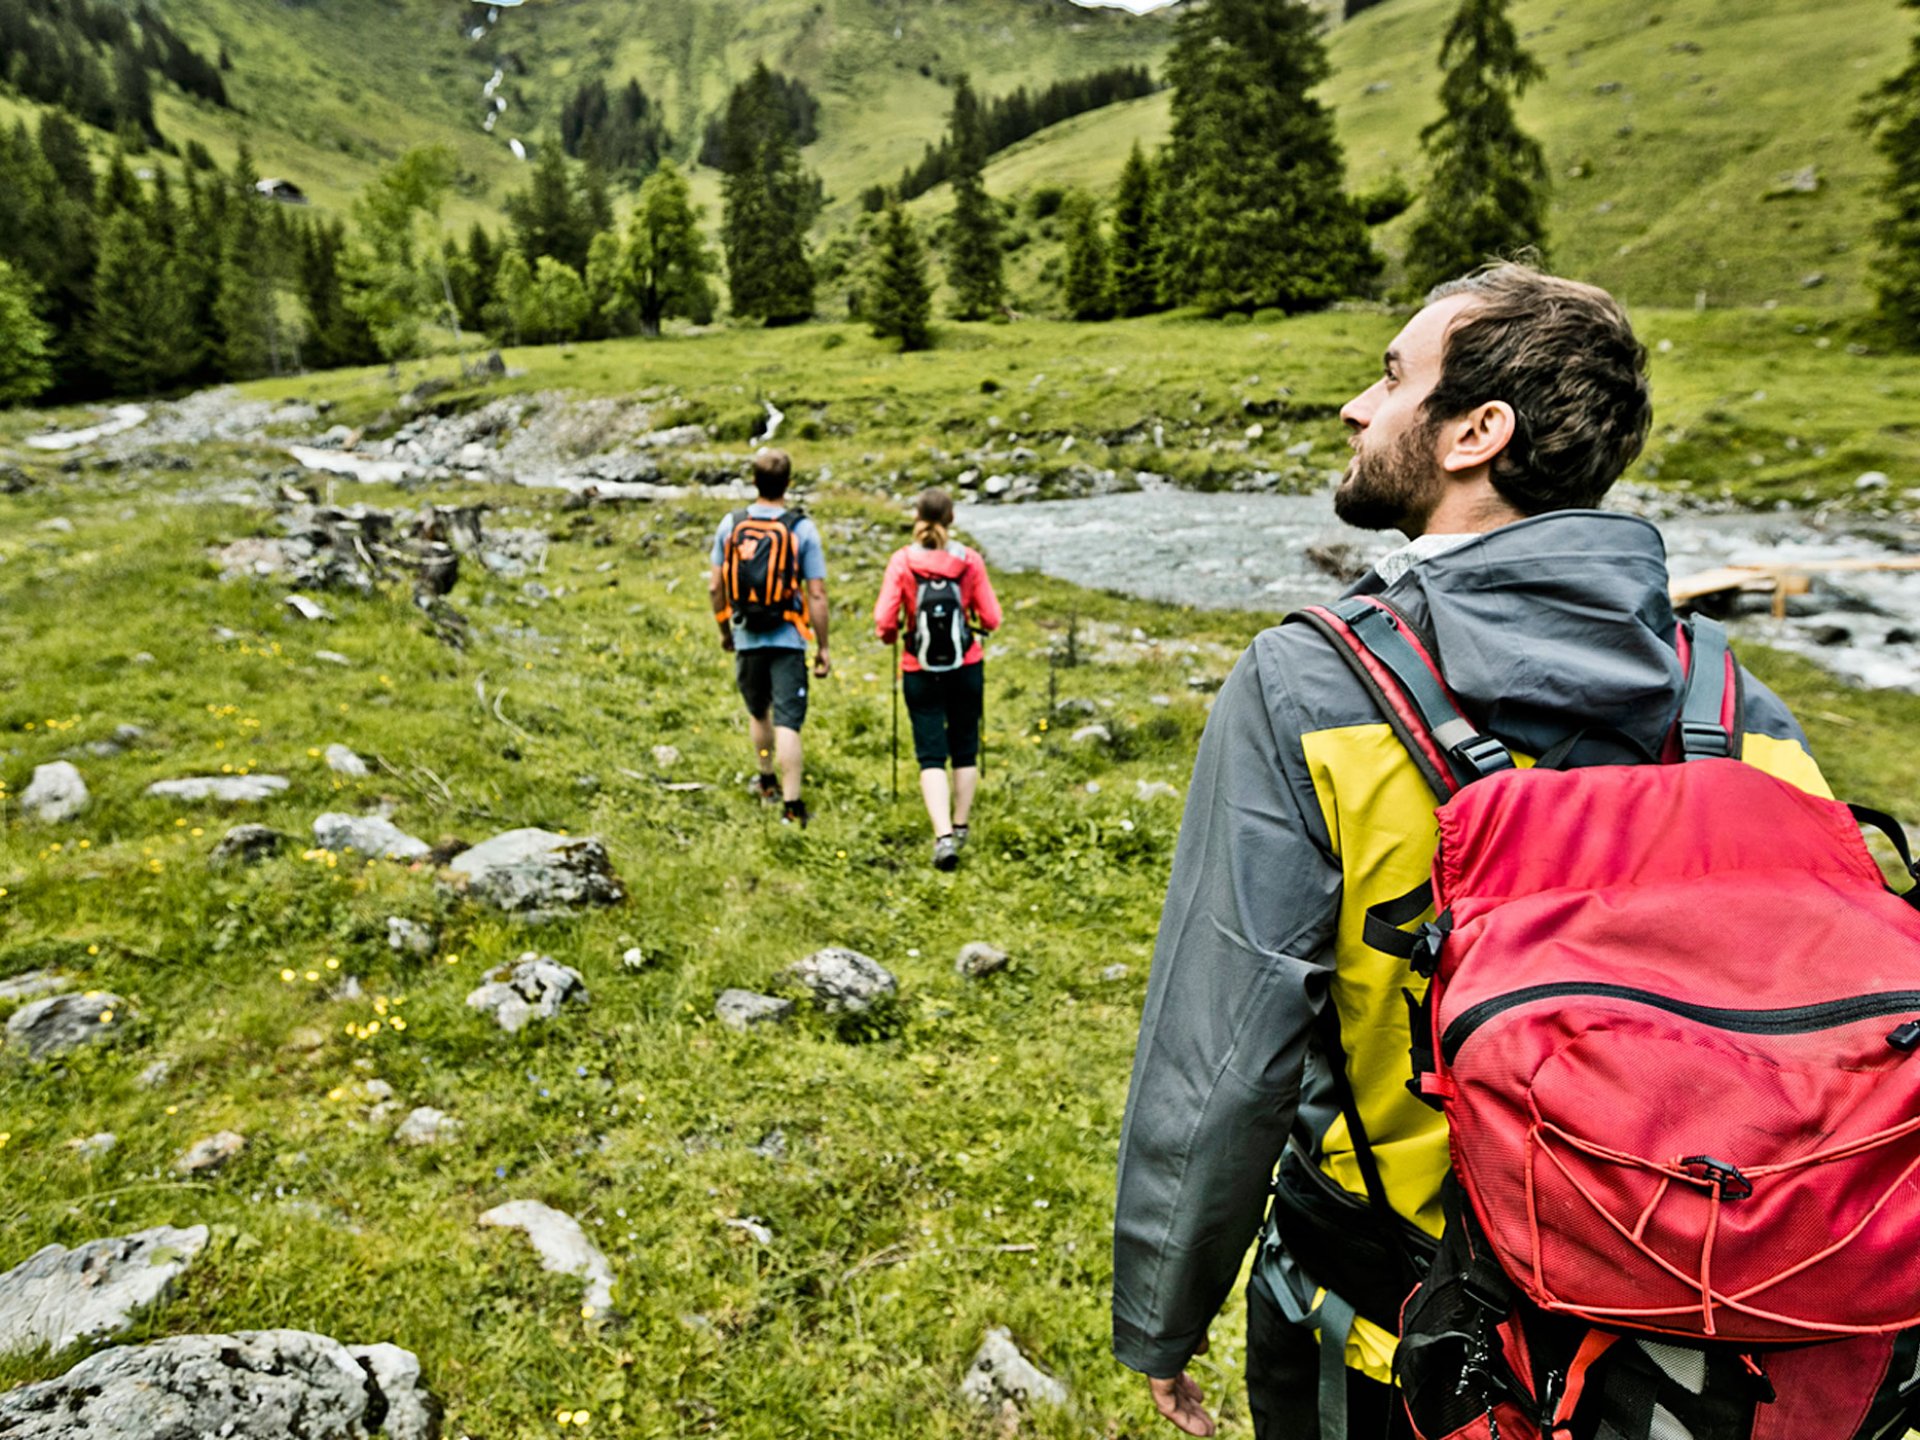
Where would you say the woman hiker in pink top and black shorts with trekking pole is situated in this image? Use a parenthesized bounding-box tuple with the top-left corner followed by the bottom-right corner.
(874, 490, 1000, 870)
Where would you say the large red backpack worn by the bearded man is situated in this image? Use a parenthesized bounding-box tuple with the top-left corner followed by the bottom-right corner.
(1300, 597, 1920, 1440)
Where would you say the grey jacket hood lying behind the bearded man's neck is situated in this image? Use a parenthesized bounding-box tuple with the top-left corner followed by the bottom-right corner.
(1356, 511, 1686, 755)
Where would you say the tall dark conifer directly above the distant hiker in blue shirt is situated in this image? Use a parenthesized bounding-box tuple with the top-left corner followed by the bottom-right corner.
(720, 63, 820, 324)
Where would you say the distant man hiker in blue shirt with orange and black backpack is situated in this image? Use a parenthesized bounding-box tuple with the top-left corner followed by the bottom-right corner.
(707, 449, 833, 828)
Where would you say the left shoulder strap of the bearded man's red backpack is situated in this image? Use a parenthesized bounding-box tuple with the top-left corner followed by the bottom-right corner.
(1283, 595, 1513, 801)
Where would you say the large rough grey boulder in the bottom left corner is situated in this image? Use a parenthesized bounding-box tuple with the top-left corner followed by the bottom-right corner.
(0, 1331, 440, 1440)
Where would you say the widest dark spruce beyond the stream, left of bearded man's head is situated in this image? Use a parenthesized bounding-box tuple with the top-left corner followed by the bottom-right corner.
(1164, 0, 1380, 313)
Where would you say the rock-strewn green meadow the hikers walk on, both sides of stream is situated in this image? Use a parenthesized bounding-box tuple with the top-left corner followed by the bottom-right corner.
(0, 315, 1920, 1436)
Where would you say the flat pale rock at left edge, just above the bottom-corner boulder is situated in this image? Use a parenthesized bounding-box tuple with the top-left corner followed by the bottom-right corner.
(0, 1221, 207, 1356)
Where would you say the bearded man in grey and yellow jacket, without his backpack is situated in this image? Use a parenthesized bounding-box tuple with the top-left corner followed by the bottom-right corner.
(1114, 265, 1826, 1440)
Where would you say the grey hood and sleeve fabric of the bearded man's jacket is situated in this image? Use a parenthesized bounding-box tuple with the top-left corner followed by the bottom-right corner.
(1114, 511, 1816, 1377)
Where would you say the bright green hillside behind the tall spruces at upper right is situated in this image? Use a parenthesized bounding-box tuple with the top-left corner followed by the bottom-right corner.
(967, 0, 1910, 307)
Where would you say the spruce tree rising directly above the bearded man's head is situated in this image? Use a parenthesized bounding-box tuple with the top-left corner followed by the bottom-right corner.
(1407, 0, 1548, 292)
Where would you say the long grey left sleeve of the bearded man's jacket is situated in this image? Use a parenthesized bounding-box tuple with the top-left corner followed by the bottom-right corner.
(1114, 632, 1340, 1379)
